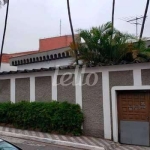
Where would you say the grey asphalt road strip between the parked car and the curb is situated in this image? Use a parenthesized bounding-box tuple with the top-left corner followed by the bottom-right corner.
(0, 136, 81, 150)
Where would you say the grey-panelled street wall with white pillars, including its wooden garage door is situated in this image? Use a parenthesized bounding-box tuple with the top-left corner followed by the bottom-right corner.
(0, 63, 150, 146)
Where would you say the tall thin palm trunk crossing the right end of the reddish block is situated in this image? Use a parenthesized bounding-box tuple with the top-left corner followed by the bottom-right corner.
(67, 0, 78, 65)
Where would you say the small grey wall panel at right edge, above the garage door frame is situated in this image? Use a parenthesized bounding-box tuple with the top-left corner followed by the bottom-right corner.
(141, 69, 150, 85)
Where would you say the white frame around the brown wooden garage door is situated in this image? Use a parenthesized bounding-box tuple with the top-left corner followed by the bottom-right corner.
(111, 86, 150, 142)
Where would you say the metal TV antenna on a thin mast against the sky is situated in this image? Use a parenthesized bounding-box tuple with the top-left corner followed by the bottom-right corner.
(121, 16, 147, 38)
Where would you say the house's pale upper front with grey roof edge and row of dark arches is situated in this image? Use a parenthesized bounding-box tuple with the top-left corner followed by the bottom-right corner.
(9, 47, 74, 70)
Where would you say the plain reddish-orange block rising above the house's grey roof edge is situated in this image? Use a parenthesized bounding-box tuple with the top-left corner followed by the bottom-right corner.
(39, 35, 72, 51)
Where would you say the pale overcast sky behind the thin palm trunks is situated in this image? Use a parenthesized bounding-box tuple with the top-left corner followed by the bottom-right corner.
(0, 0, 150, 53)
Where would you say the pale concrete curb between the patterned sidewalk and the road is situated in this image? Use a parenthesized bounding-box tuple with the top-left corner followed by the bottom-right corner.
(0, 131, 105, 150)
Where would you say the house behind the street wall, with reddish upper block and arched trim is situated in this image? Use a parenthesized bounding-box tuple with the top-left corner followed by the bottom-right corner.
(1, 35, 74, 72)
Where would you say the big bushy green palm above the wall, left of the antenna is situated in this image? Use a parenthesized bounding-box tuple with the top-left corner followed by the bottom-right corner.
(70, 22, 134, 65)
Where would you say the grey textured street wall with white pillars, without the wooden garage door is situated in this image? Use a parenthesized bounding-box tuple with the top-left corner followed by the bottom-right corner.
(0, 63, 150, 139)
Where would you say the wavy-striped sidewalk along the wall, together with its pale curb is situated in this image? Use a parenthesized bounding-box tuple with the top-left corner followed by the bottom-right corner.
(0, 127, 150, 150)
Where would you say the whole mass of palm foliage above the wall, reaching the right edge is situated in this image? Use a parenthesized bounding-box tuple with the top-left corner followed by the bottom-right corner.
(69, 22, 149, 66)
